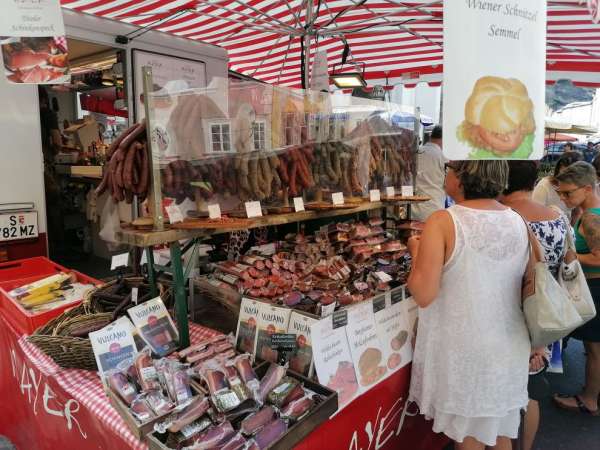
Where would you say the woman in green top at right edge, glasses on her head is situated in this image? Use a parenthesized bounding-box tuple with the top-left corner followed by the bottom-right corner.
(554, 161, 600, 416)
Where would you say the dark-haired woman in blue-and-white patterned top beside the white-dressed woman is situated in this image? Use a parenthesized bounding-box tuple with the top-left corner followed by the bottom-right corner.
(500, 161, 570, 450)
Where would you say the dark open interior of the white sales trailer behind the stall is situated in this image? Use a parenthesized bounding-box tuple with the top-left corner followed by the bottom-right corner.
(39, 39, 130, 270)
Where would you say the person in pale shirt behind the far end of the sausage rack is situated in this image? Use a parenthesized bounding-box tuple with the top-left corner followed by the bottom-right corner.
(411, 125, 446, 222)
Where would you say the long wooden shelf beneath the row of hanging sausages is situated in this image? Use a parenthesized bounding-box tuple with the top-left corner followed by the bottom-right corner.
(116, 197, 429, 247)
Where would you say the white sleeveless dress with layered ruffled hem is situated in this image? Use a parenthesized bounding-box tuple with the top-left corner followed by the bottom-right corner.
(409, 205, 531, 446)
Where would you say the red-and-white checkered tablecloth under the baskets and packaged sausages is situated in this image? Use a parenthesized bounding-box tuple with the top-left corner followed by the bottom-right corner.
(18, 324, 218, 450)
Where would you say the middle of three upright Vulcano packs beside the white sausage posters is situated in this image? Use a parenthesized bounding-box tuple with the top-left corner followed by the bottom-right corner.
(254, 303, 292, 362)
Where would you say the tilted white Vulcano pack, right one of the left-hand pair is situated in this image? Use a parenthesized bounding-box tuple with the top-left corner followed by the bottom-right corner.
(127, 297, 179, 356)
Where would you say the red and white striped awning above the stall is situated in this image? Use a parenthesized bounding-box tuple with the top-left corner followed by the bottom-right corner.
(61, 0, 600, 87)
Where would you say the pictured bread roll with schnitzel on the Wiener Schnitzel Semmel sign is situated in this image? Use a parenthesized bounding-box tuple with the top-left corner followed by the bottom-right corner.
(459, 76, 535, 156)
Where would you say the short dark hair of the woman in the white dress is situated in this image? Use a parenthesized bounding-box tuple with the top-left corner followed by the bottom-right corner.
(452, 160, 508, 200)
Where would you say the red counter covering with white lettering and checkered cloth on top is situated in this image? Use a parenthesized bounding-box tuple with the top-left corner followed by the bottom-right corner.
(0, 317, 447, 450)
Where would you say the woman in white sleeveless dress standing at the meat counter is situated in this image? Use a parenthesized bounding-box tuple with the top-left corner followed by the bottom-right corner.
(408, 161, 531, 450)
